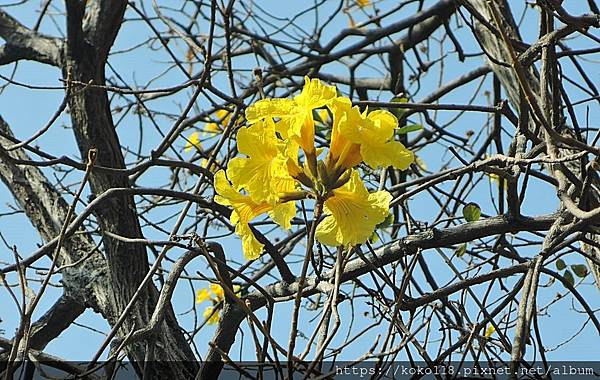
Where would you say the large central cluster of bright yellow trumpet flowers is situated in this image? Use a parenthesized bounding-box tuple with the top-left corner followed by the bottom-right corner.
(214, 78, 414, 260)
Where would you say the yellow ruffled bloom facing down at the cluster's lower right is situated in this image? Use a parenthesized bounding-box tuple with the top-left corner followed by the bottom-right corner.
(316, 170, 392, 246)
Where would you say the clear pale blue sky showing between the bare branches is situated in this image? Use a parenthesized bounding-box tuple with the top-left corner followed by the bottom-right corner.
(0, 0, 600, 360)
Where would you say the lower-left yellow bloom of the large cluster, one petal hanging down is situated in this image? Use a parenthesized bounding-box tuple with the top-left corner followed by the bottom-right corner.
(214, 170, 273, 260)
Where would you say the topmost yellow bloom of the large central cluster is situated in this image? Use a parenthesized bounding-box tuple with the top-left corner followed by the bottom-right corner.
(246, 77, 336, 155)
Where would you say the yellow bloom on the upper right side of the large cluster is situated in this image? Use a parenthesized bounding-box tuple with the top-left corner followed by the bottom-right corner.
(331, 98, 414, 170)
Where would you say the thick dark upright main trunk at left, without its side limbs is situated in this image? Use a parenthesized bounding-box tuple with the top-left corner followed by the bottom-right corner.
(63, 0, 196, 378)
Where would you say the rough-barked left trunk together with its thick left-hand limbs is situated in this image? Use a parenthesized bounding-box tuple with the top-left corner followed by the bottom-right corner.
(0, 0, 196, 378)
